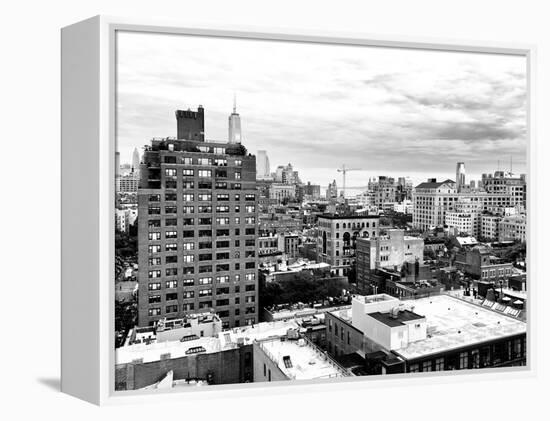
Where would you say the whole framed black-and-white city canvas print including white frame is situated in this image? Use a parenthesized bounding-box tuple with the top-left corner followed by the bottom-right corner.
(62, 17, 536, 403)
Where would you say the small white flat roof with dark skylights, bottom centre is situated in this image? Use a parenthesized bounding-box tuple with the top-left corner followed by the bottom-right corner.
(259, 339, 347, 380)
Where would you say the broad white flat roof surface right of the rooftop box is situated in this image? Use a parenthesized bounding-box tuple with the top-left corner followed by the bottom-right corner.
(393, 294, 527, 359)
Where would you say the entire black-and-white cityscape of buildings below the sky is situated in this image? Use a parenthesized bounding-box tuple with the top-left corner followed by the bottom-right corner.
(115, 100, 527, 390)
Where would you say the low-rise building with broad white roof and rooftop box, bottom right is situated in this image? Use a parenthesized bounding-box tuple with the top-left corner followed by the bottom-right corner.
(325, 294, 527, 374)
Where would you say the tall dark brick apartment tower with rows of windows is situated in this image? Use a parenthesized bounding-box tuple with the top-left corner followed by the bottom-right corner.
(138, 108, 258, 327)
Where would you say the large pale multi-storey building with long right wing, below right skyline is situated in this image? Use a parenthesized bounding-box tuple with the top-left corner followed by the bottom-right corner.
(413, 178, 523, 230)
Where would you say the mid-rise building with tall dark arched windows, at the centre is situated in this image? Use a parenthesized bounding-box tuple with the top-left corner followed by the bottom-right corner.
(317, 215, 380, 276)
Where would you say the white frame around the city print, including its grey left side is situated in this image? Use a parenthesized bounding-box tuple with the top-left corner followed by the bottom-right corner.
(61, 16, 538, 405)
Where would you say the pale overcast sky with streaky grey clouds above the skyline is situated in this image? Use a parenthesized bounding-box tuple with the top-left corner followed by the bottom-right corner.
(117, 33, 527, 187)
